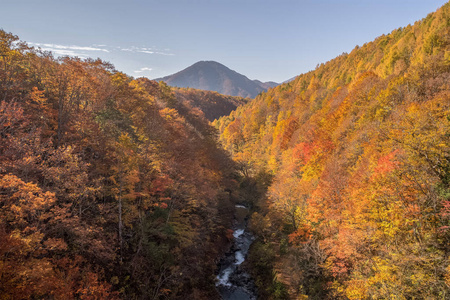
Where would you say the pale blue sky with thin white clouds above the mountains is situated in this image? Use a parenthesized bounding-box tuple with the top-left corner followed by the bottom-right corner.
(0, 0, 447, 82)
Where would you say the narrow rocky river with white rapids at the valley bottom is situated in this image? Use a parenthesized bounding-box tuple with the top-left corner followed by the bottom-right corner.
(216, 205, 257, 300)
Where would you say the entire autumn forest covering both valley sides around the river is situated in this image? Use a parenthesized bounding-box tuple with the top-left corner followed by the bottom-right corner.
(0, 3, 450, 300)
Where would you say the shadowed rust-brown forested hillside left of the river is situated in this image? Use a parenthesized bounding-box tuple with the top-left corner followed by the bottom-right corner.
(0, 31, 243, 299)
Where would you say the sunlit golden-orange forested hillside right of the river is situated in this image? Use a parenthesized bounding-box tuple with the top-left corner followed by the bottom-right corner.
(215, 3, 450, 299)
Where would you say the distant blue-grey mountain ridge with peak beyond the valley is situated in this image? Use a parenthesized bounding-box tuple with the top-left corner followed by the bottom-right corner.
(155, 61, 278, 98)
